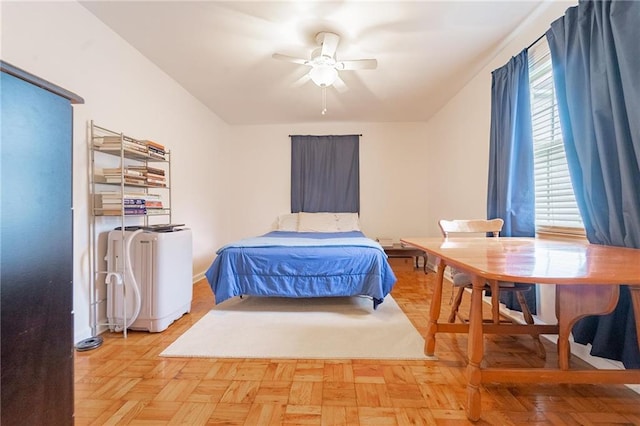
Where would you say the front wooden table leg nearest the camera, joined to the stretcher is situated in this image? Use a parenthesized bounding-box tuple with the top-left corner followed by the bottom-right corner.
(467, 276, 485, 421)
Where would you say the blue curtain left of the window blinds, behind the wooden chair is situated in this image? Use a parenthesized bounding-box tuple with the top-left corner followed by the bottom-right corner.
(487, 49, 536, 313)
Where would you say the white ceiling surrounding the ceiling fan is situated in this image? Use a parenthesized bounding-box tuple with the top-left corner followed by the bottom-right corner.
(82, 0, 544, 124)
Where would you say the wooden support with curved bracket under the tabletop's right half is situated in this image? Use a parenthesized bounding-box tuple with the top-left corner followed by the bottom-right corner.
(556, 285, 620, 370)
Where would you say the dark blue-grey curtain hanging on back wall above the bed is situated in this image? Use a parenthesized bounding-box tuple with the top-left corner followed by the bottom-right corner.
(291, 135, 360, 213)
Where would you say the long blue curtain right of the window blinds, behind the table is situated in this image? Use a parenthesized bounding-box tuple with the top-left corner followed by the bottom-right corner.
(546, 1, 640, 368)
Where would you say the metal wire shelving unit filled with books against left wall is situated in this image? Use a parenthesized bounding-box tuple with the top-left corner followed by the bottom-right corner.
(88, 121, 171, 337)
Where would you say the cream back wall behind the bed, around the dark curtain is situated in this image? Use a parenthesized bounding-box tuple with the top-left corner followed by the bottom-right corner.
(225, 123, 430, 245)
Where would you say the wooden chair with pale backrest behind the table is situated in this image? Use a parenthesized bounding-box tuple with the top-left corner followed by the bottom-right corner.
(438, 218, 546, 358)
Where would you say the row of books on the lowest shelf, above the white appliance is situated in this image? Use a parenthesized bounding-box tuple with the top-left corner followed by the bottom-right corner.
(94, 191, 164, 216)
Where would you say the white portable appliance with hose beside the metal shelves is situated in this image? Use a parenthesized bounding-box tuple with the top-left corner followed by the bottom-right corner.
(106, 229, 193, 332)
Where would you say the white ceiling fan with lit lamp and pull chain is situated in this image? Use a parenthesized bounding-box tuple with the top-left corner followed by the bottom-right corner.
(272, 31, 378, 114)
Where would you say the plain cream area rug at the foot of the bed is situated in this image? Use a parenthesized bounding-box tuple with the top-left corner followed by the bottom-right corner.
(160, 296, 425, 359)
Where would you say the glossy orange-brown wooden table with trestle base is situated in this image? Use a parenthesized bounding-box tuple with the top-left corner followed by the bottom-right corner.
(401, 237, 640, 421)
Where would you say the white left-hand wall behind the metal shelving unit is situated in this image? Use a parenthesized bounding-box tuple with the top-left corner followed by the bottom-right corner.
(1, 2, 230, 341)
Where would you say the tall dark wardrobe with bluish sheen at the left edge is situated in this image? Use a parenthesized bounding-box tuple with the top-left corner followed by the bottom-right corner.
(0, 62, 82, 426)
